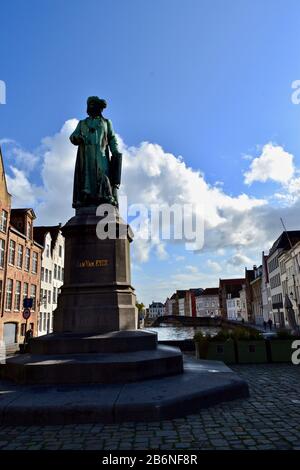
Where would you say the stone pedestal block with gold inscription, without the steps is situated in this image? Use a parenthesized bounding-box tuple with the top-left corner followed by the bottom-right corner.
(53, 208, 137, 334)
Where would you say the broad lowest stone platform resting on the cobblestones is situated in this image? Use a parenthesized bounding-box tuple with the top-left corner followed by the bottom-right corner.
(0, 358, 249, 425)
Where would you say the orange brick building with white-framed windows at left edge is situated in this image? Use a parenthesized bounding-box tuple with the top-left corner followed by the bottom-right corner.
(0, 149, 42, 350)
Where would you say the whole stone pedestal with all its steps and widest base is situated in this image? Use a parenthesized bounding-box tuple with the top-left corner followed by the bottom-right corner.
(0, 206, 249, 418)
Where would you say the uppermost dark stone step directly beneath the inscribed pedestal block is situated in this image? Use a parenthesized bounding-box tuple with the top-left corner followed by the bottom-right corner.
(30, 330, 157, 354)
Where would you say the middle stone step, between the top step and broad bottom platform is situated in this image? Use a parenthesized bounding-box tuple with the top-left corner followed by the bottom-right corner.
(2, 346, 183, 384)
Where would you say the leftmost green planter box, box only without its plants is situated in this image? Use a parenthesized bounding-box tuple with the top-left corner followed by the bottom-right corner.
(195, 340, 236, 364)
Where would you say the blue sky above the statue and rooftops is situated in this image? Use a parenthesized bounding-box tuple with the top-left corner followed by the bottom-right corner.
(0, 0, 300, 302)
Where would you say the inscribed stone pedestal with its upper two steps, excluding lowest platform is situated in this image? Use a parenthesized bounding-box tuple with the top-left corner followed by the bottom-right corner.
(3, 208, 183, 385)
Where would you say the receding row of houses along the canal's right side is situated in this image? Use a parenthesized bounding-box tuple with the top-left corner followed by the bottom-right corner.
(148, 230, 300, 329)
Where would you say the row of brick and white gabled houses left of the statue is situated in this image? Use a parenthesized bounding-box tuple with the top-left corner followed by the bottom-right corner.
(0, 149, 64, 349)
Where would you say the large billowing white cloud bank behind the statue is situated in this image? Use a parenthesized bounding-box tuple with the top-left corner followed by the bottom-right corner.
(4, 119, 299, 274)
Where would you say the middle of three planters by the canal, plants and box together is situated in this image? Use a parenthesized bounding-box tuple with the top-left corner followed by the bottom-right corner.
(233, 328, 268, 364)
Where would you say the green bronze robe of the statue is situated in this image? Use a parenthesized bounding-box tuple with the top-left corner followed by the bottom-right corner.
(70, 116, 119, 208)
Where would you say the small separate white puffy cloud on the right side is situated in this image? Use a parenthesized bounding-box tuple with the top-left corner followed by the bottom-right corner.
(244, 143, 295, 185)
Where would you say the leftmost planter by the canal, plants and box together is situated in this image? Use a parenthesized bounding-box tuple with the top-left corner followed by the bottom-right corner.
(194, 328, 236, 364)
